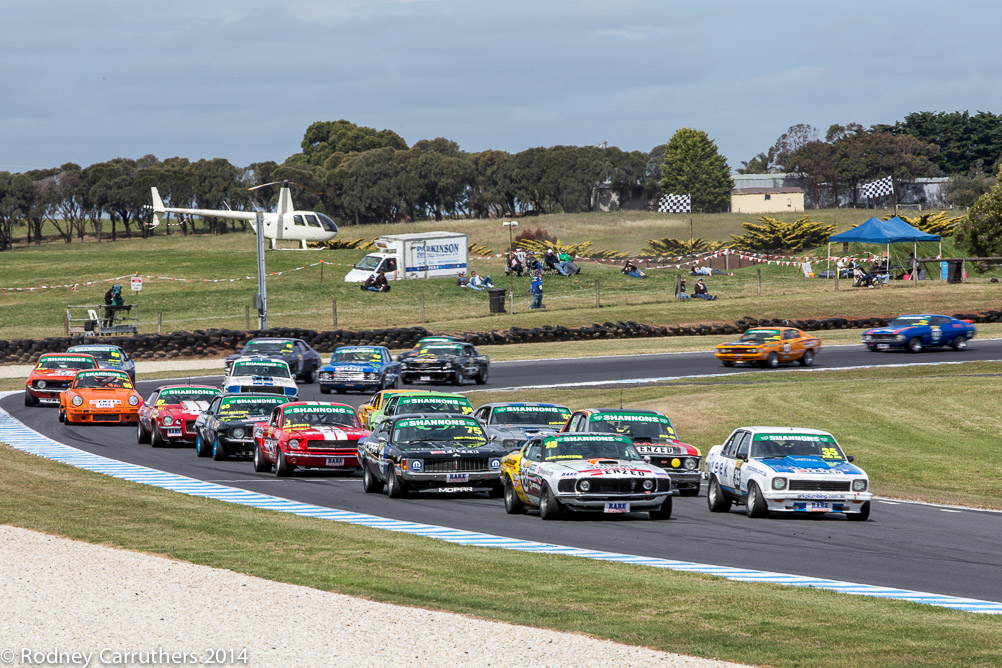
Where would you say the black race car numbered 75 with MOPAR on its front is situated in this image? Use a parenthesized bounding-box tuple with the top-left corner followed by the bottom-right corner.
(359, 414, 505, 499)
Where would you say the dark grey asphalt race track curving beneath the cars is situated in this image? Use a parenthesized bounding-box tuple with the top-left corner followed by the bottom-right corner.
(2, 340, 1002, 602)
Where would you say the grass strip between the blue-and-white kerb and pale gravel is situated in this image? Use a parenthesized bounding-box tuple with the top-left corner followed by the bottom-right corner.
(0, 447, 1002, 666)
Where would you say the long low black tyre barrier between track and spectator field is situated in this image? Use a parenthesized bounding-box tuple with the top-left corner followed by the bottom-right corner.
(0, 310, 1002, 365)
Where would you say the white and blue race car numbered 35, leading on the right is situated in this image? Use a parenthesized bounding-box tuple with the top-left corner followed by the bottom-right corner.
(705, 427, 873, 522)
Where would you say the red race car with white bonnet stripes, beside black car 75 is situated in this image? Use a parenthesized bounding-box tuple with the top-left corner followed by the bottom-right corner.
(254, 402, 370, 477)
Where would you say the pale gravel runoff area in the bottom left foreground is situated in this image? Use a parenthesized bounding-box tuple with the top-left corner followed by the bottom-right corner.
(0, 525, 736, 668)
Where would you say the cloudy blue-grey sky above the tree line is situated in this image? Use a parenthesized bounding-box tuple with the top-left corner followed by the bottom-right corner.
(0, 0, 1002, 171)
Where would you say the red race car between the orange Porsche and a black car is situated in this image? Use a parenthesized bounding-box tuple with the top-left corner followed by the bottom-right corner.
(135, 385, 222, 448)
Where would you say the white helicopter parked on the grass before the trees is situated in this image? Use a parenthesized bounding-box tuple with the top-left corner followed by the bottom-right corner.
(150, 181, 338, 250)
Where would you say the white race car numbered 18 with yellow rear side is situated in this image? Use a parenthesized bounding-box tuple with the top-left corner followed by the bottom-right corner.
(501, 434, 678, 520)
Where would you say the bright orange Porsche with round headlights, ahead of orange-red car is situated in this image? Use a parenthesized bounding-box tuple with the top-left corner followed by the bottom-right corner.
(59, 369, 142, 424)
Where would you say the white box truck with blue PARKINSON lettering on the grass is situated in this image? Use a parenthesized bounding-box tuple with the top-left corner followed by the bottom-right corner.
(345, 232, 469, 283)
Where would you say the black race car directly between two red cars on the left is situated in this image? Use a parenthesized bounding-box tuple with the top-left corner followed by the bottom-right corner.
(194, 393, 289, 461)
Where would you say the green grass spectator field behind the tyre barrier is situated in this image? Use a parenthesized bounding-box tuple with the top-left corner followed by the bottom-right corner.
(0, 209, 985, 339)
